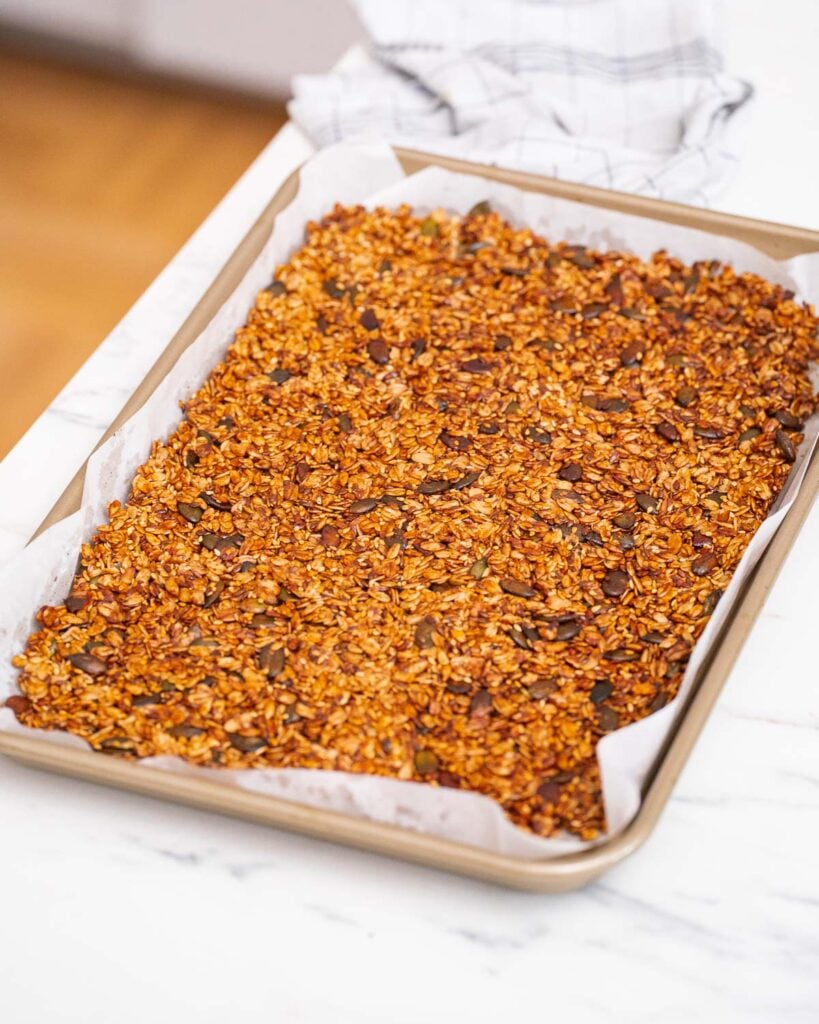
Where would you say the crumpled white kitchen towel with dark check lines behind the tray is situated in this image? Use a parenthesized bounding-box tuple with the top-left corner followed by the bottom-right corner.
(289, 0, 752, 205)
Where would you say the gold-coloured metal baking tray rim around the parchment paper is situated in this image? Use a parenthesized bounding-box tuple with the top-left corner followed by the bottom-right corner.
(0, 150, 819, 892)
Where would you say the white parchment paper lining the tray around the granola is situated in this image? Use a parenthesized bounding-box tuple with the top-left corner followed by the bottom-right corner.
(0, 138, 819, 858)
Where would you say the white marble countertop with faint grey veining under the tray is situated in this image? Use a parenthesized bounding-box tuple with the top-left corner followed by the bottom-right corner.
(0, 8, 819, 1024)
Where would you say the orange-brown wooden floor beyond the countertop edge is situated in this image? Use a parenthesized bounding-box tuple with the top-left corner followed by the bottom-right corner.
(0, 49, 285, 457)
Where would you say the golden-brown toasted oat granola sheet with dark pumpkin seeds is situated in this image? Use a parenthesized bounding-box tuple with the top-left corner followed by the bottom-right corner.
(9, 204, 817, 838)
